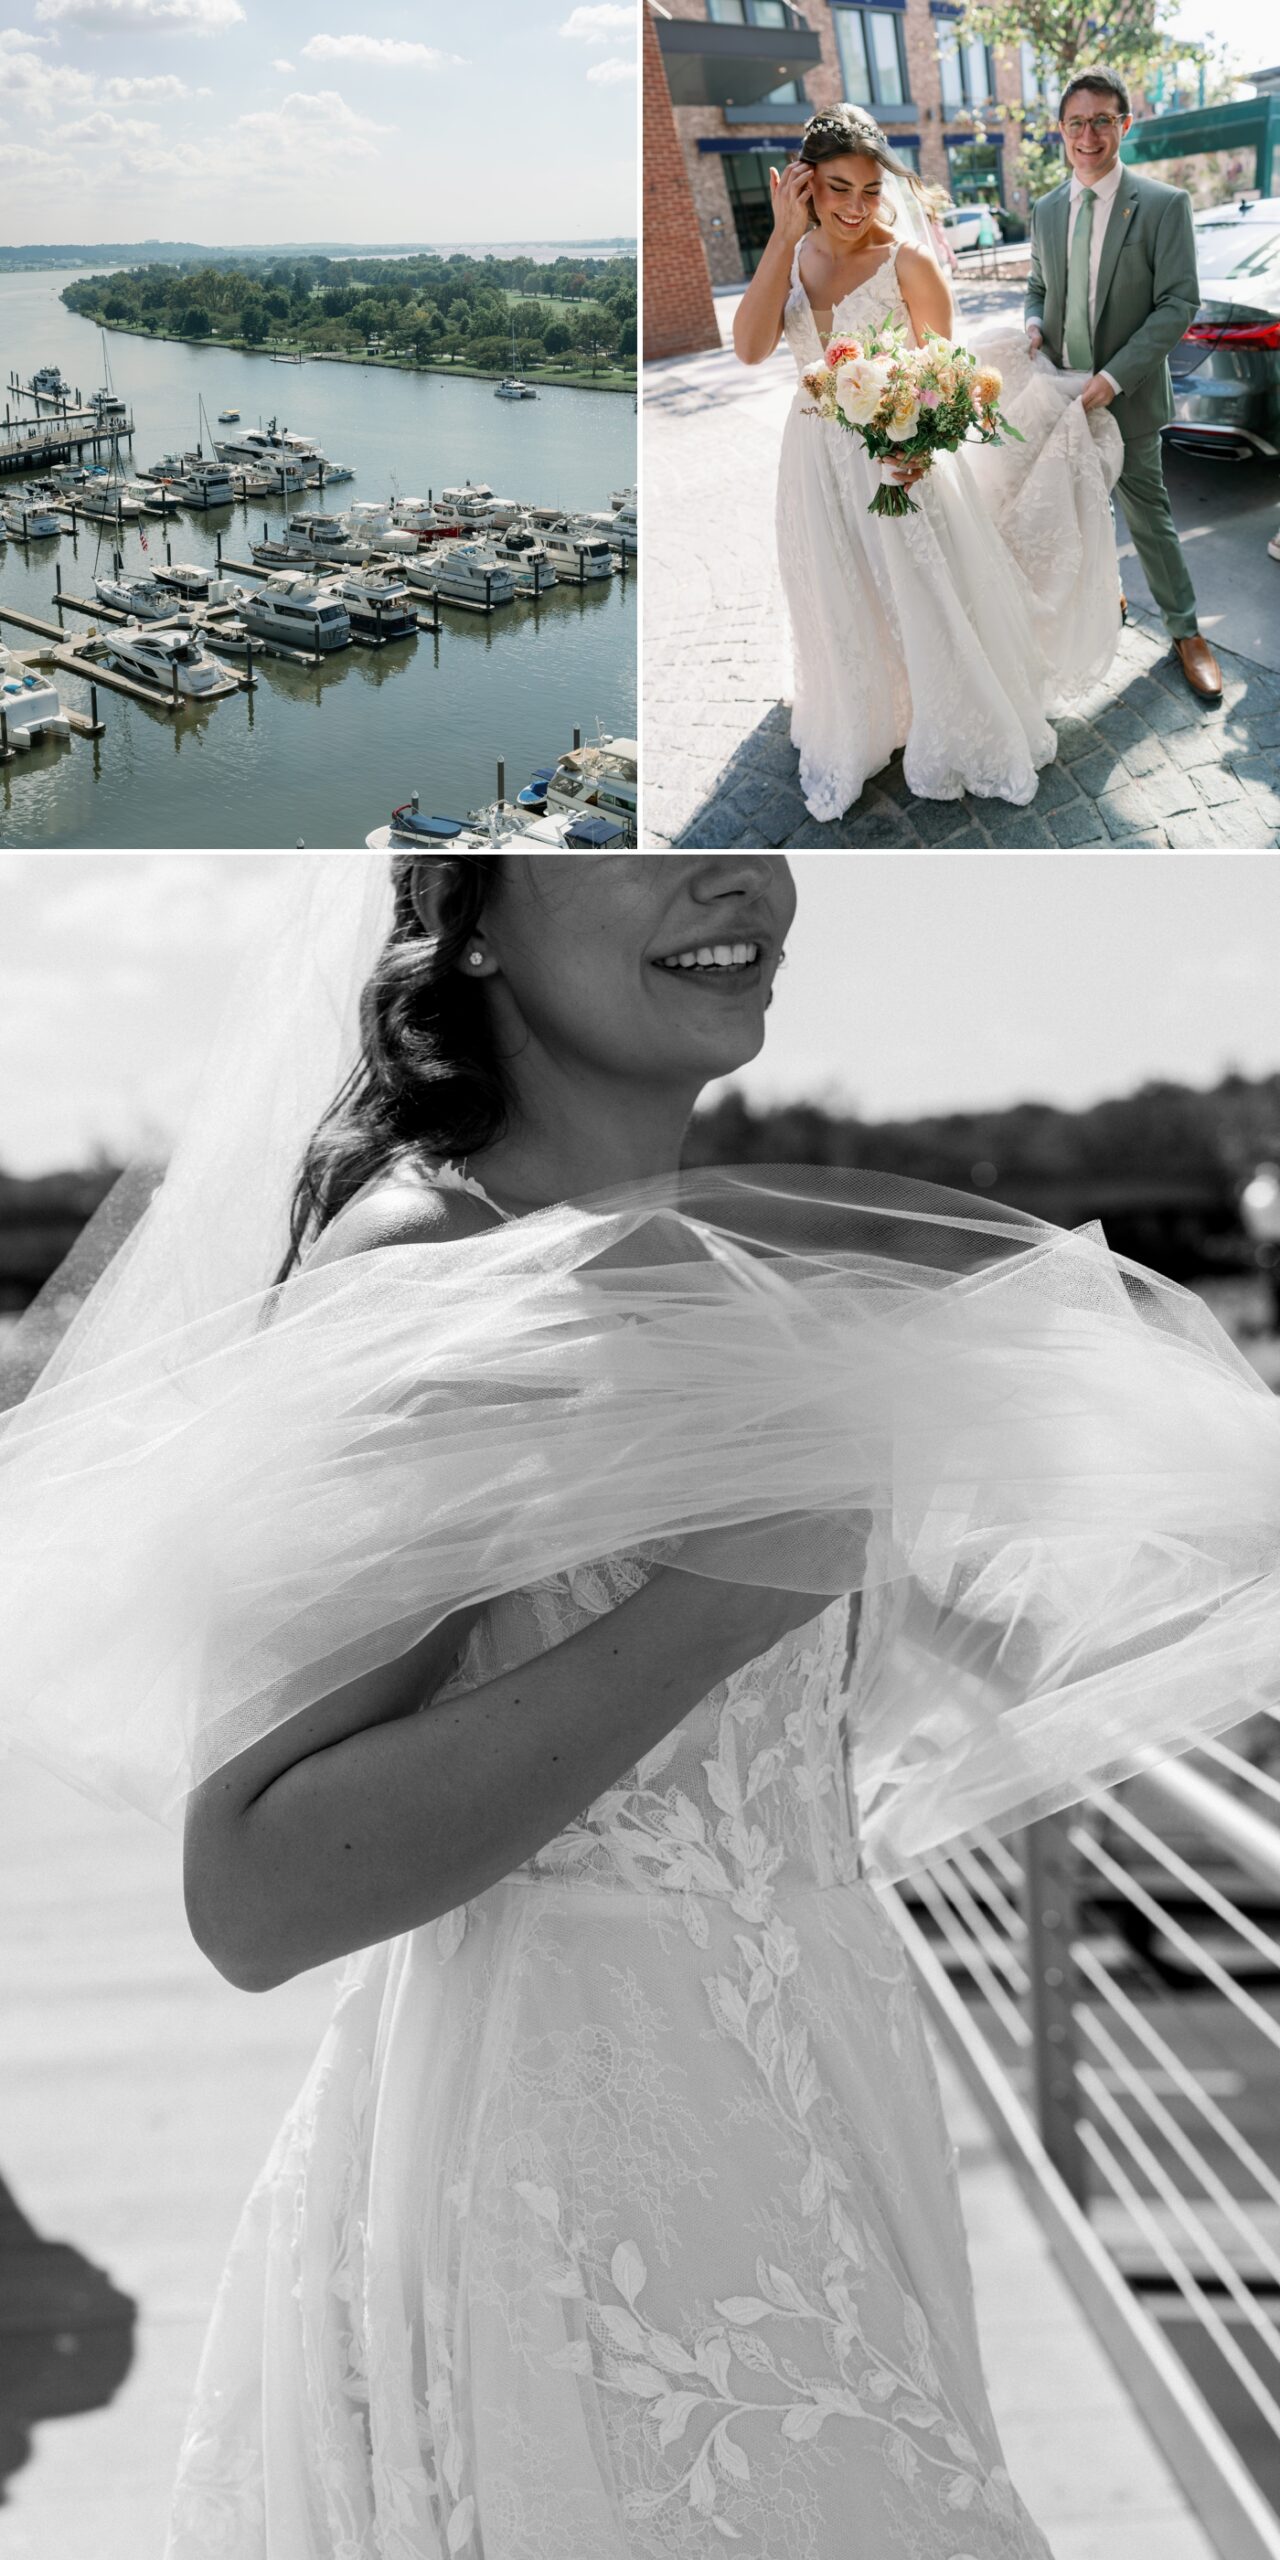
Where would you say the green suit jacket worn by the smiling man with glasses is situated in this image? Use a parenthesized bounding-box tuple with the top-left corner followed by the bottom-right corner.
(1024, 169, 1201, 438)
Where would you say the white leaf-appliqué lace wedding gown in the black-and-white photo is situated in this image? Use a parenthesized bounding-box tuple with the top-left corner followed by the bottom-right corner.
(169, 1559, 1050, 2560)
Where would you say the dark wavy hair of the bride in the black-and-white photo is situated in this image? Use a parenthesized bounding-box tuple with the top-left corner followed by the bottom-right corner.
(276, 852, 507, 1283)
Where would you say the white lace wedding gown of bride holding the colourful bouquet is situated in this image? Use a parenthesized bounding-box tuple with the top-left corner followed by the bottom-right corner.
(778, 248, 1121, 822)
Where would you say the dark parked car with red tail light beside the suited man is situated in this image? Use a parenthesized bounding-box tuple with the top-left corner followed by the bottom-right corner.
(1165, 195, 1280, 461)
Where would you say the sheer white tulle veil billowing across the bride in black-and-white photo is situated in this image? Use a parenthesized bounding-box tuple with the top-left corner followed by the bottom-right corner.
(0, 855, 1280, 1876)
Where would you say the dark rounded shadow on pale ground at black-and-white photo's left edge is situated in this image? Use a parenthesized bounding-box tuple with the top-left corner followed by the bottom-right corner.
(0, 2179, 136, 2506)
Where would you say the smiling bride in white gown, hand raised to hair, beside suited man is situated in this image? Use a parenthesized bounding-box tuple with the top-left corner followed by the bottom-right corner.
(735, 105, 1121, 822)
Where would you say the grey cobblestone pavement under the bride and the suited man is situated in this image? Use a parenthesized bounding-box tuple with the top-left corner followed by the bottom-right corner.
(643, 320, 1280, 852)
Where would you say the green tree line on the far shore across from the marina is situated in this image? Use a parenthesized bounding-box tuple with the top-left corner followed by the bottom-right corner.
(61, 253, 637, 371)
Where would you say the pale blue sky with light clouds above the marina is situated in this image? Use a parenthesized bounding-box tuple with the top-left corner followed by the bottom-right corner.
(0, 0, 637, 246)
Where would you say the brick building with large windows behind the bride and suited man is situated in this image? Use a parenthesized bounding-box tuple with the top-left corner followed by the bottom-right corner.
(645, 0, 1052, 291)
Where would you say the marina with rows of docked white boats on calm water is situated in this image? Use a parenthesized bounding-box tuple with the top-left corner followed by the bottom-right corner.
(0, 274, 637, 847)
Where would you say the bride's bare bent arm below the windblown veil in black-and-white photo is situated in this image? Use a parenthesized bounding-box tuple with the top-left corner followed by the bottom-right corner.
(184, 1193, 824, 1992)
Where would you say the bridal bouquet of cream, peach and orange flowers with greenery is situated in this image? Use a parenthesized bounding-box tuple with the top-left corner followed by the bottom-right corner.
(804, 320, 1024, 515)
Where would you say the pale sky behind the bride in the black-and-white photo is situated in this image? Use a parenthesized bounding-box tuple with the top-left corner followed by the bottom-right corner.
(0, 852, 1280, 1172)
